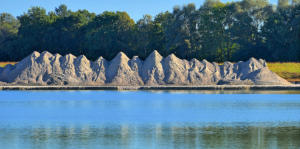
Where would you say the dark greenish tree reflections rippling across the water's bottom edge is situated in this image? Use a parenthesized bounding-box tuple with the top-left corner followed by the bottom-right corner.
(0, 124, 300, 149)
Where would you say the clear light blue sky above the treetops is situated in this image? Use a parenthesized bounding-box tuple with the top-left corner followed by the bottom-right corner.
(0, 0, 274, 21)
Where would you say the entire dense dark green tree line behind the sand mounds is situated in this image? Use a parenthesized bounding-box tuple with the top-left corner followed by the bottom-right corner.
(0, 0, 300, 62)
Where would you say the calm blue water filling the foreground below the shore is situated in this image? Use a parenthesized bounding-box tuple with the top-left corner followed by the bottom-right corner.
(0, 91, 300, 149)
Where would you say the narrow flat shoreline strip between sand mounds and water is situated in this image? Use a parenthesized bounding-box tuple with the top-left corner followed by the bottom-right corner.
(0, 85, 300, 91)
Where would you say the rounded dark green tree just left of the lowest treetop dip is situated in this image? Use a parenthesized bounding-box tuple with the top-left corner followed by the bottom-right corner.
(85, 11, 135, 59)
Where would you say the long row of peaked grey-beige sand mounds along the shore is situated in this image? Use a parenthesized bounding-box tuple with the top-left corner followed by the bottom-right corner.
(0, 51, 290, 86)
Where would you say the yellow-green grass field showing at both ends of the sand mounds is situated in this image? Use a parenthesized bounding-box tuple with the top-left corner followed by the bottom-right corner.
(0, 62, 300, 81)
